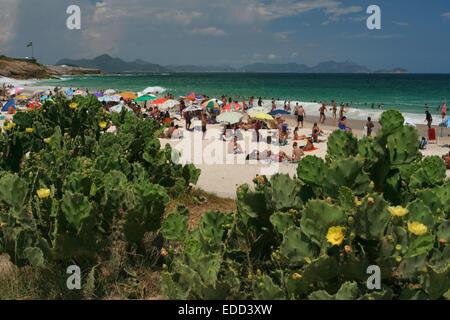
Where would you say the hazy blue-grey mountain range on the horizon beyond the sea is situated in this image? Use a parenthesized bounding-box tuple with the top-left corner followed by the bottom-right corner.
(56, 54, 407, 73)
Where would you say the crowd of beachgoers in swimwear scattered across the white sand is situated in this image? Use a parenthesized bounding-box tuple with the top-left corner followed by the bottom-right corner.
(0, 84, 450, 169)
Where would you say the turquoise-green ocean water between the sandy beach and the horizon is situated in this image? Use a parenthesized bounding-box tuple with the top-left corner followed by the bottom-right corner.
(40, 73, 450, 114)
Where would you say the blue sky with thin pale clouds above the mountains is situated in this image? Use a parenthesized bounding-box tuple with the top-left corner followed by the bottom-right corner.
(0, 0, 450, 73)
